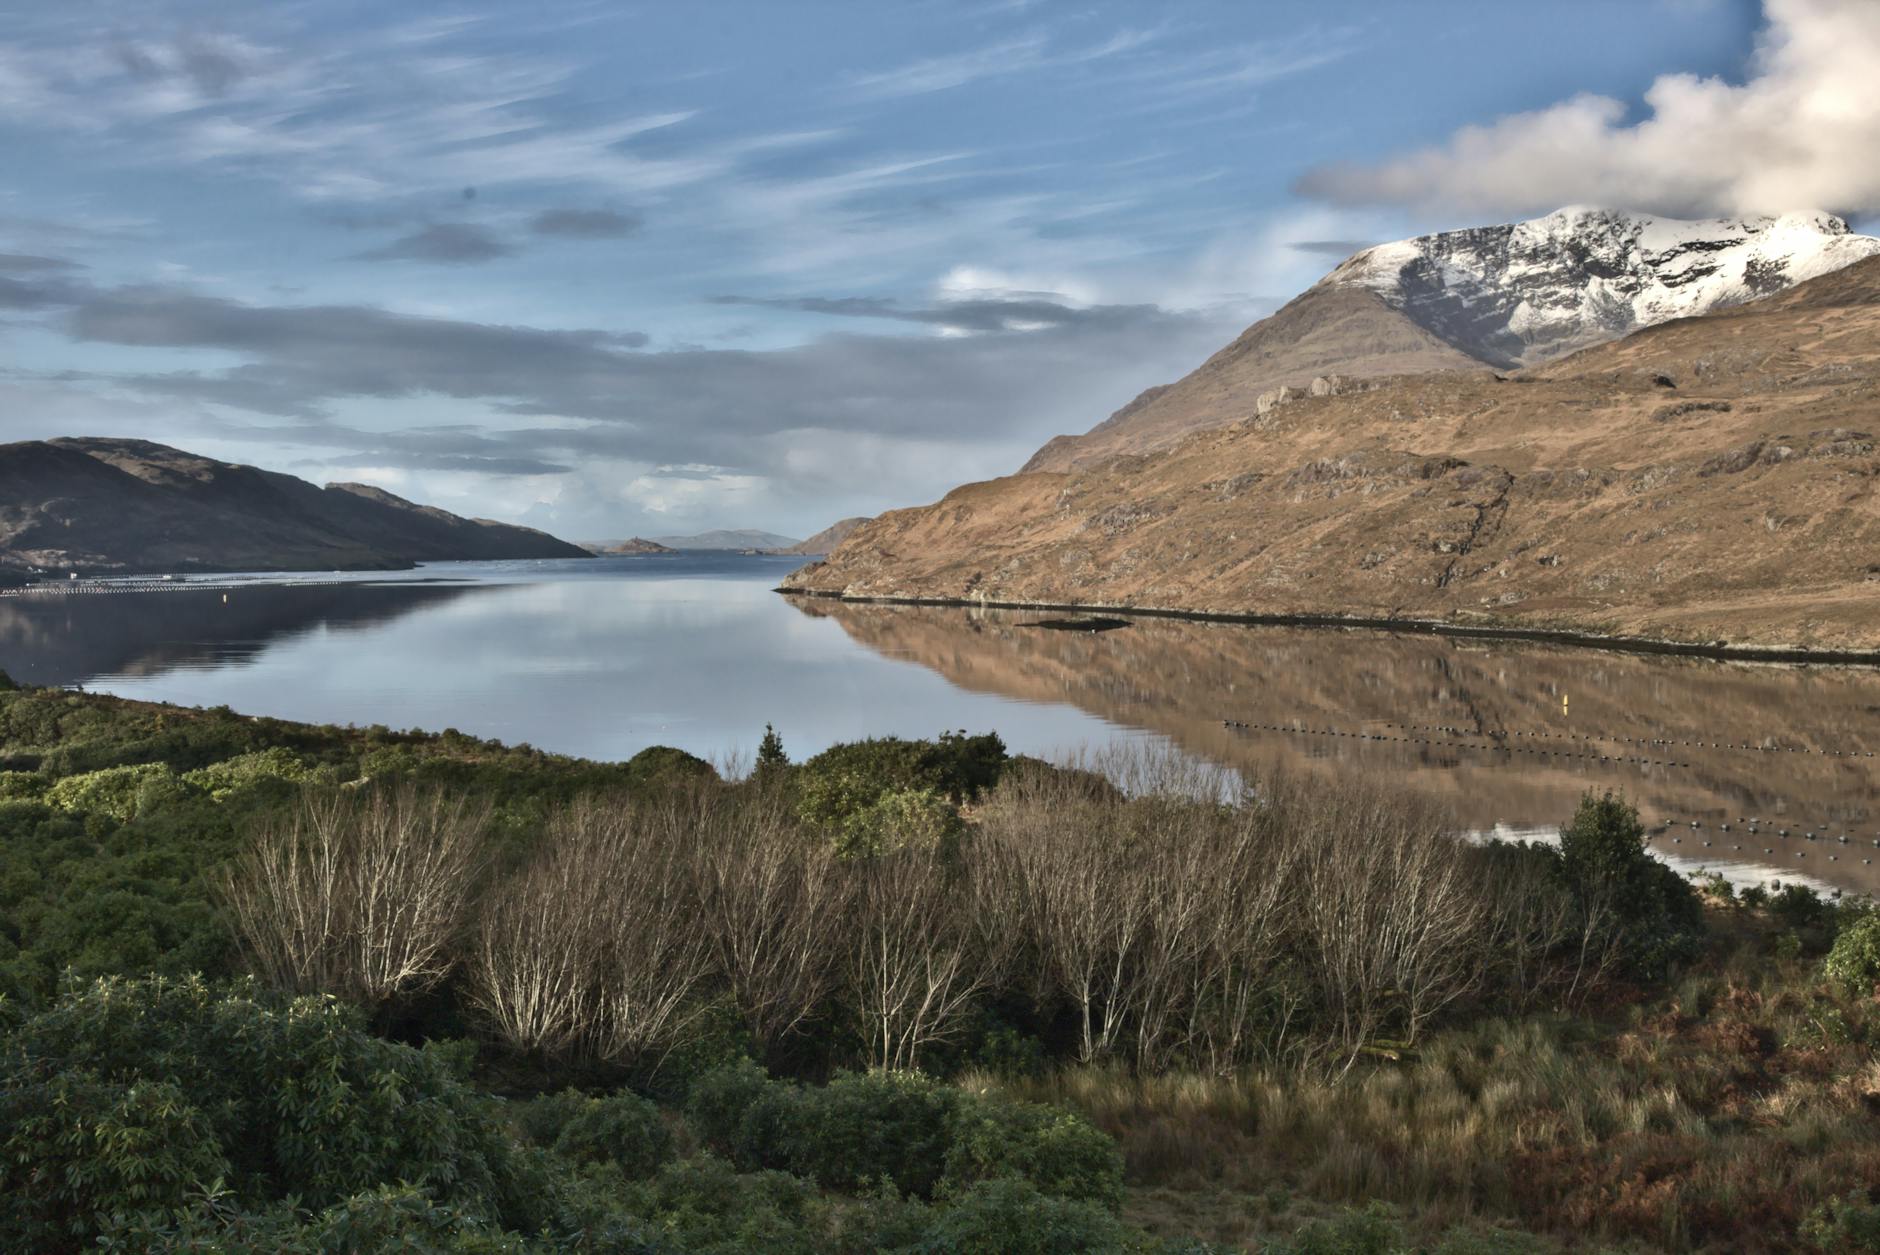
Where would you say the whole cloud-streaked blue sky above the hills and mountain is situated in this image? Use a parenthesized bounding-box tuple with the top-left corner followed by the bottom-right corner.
(0, 0, 1880, 539)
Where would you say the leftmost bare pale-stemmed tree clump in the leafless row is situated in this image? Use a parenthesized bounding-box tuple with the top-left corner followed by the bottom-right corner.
(222, 785, 489, 1005)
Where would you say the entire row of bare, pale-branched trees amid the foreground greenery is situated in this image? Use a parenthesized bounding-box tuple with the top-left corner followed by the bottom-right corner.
(227, 757, 1615, 1071)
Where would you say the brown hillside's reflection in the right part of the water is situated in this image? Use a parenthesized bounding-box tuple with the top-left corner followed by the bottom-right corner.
(793, 597, 1880, 891)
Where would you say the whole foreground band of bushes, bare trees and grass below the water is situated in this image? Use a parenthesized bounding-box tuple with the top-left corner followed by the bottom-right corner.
(0, 689, 1880, 1253)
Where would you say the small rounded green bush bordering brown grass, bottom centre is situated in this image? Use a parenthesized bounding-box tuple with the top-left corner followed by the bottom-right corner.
(946, 1095, 1122, 1210)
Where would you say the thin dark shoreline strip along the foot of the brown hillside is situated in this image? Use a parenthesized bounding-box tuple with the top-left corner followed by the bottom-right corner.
(771, 584, 1880, 667)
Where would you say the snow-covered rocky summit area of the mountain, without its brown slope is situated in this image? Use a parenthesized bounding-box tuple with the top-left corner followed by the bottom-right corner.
(1318, 207, 1880, 366)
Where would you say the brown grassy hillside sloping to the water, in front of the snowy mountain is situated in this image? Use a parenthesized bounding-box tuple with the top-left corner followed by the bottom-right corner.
(790, 251, 1880, 648)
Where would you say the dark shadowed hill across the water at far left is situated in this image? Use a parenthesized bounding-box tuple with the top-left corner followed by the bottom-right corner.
(0, 438, 588, 575)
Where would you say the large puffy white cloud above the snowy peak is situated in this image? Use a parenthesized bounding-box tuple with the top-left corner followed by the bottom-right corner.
(1299, 0, 1880, 216)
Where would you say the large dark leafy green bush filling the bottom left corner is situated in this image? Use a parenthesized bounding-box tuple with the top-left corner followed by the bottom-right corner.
(0, 979, 540, 1249)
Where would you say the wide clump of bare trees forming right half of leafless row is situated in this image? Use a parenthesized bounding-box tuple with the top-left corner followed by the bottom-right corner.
(972, 759, 1598, 1071)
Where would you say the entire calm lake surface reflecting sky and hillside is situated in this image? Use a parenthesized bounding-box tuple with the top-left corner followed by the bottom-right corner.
(0, 552, 1880, 892)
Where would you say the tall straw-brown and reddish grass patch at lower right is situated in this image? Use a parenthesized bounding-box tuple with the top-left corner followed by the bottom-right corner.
(963, 919, 1880, 1251)
